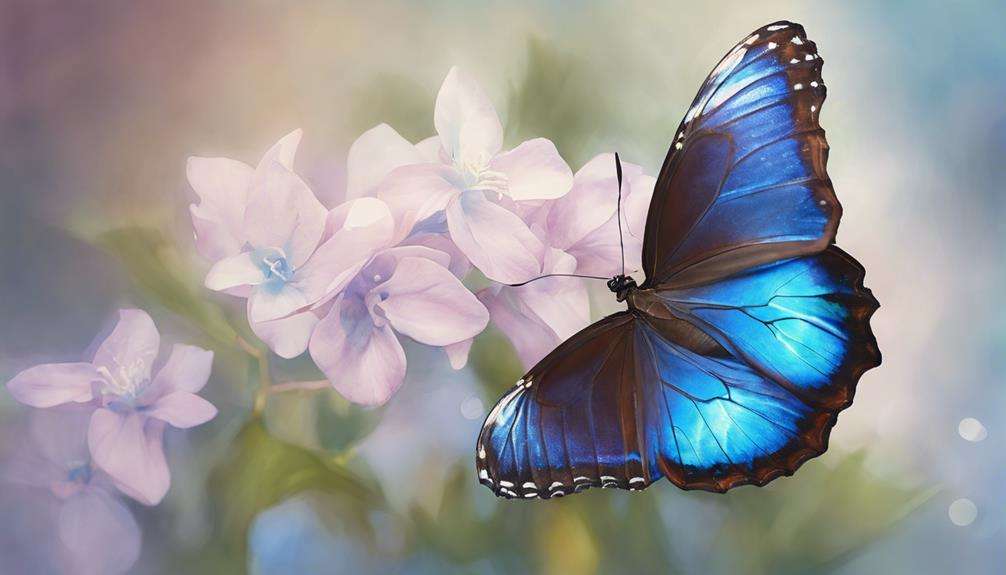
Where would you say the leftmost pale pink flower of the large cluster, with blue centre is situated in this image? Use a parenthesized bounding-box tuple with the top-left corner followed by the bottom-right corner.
(189, 132, 400, 358)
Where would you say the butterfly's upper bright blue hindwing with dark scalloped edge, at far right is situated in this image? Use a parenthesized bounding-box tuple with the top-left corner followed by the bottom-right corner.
(662, 246, 880, 409)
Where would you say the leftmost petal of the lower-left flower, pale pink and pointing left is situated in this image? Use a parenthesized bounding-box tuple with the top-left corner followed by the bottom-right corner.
(7, 363, 102, 407)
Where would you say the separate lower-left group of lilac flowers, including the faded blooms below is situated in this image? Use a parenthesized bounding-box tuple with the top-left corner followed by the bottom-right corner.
(7, 310, 216, 573)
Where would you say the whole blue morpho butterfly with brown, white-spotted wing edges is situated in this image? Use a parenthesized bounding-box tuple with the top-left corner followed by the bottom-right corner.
(476, 21, 880, 499)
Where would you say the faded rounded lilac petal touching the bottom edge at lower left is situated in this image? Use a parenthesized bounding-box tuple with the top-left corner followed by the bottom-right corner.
(58, 489, 141, 575)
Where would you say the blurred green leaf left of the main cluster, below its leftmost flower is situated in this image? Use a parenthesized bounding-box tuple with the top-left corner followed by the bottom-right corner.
(95, 226, 236, 348)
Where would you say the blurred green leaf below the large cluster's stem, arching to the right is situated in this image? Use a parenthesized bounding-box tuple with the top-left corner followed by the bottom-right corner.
(209, 419, 384, 557)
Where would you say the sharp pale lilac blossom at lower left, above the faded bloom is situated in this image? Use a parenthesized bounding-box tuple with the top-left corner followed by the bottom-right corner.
(7, 310, 216, 505)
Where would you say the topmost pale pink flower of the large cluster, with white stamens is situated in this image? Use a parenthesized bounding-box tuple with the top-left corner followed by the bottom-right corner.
(374, 68, 572, 282)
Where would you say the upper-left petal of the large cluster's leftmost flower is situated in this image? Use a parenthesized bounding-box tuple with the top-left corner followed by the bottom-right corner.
(185, 157, 255, 260)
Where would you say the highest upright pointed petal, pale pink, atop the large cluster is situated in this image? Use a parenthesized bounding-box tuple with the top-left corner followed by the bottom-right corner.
(434, 66, 503, 165)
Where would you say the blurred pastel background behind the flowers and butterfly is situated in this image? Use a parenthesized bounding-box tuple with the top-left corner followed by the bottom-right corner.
(0, 0, 1006, 574)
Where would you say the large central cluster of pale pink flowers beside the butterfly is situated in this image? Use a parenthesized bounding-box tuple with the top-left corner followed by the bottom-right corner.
(187, 68, 654, 405)
